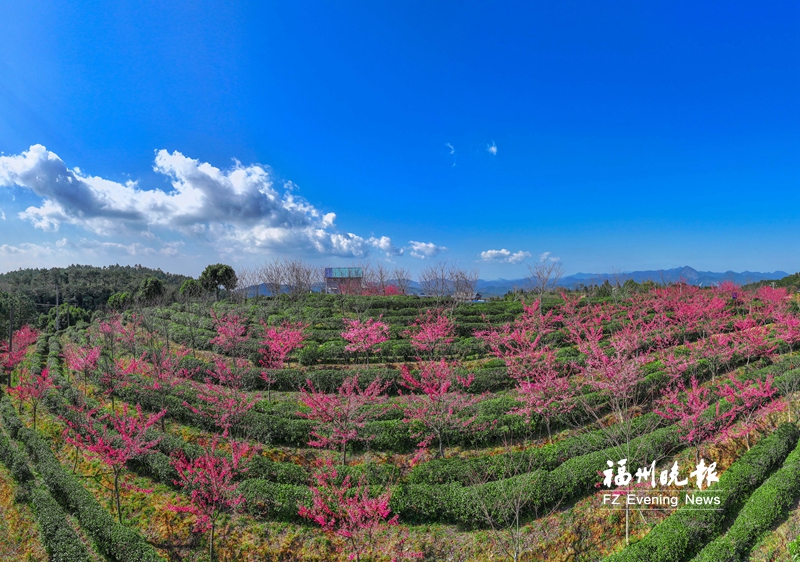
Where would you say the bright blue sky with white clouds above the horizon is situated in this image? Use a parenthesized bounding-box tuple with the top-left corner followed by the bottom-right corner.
(0, 0, 800, 278)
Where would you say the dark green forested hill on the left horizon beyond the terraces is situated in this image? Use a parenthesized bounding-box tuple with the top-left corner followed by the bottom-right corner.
(0, 265, 190, 310)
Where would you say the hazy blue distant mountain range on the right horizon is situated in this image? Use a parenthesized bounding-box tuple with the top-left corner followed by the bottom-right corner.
(477, 265, 789, 295)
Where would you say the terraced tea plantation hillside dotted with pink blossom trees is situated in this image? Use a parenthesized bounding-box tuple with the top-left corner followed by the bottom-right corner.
(0, 279, 800, 562)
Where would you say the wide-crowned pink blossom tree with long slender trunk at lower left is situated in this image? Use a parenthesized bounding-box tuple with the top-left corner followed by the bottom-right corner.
(64, 404, 166, 523)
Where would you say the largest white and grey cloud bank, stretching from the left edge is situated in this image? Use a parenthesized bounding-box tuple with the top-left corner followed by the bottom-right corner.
(0, 145, 402, 257)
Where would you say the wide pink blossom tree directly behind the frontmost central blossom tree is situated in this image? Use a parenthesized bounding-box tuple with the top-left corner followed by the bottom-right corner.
(298, 374, 390, 466)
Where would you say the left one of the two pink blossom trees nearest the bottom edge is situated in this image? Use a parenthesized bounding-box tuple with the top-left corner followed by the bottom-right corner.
(167, 436, 255, 562)
